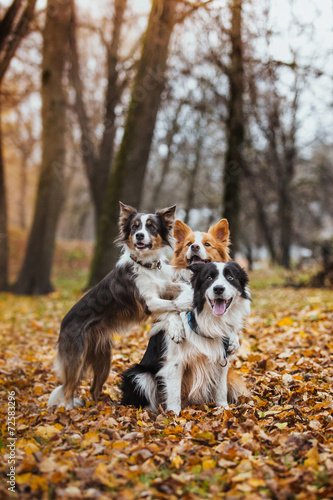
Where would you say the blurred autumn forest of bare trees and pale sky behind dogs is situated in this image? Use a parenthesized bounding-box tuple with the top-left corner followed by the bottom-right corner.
(0, 0, 333, 294)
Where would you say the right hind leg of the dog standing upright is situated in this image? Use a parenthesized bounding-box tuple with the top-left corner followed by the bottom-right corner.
(90, 337, 112, 401)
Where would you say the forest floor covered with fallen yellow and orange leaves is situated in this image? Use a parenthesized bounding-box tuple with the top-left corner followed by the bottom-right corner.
(0, 236, 333, 500)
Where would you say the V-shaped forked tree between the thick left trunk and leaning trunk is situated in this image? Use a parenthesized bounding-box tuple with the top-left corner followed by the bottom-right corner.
(69, 0, 127, 230)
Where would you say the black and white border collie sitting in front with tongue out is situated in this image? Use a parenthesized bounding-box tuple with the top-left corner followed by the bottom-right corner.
(121, 261, 251, 414)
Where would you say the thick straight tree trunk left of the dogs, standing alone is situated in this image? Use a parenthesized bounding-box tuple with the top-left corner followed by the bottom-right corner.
(15, 0, 70, 295)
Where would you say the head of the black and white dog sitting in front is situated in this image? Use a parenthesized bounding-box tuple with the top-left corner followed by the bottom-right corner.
(189, 262, 249, 316)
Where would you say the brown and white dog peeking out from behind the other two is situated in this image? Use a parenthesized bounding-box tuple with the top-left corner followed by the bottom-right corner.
(150, 219, 250, 404)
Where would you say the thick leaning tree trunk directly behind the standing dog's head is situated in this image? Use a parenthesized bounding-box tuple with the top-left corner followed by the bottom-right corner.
(89, 0, 177, 286)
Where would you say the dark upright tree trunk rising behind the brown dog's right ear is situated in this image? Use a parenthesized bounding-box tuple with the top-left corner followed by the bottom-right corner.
(223, 0, 244, 256)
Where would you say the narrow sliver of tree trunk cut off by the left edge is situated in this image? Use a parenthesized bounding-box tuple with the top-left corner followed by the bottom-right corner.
(0, 108, 8, 292)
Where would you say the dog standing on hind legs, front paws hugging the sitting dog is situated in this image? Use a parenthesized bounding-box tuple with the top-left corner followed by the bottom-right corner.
(48, 203, 193, 409)
